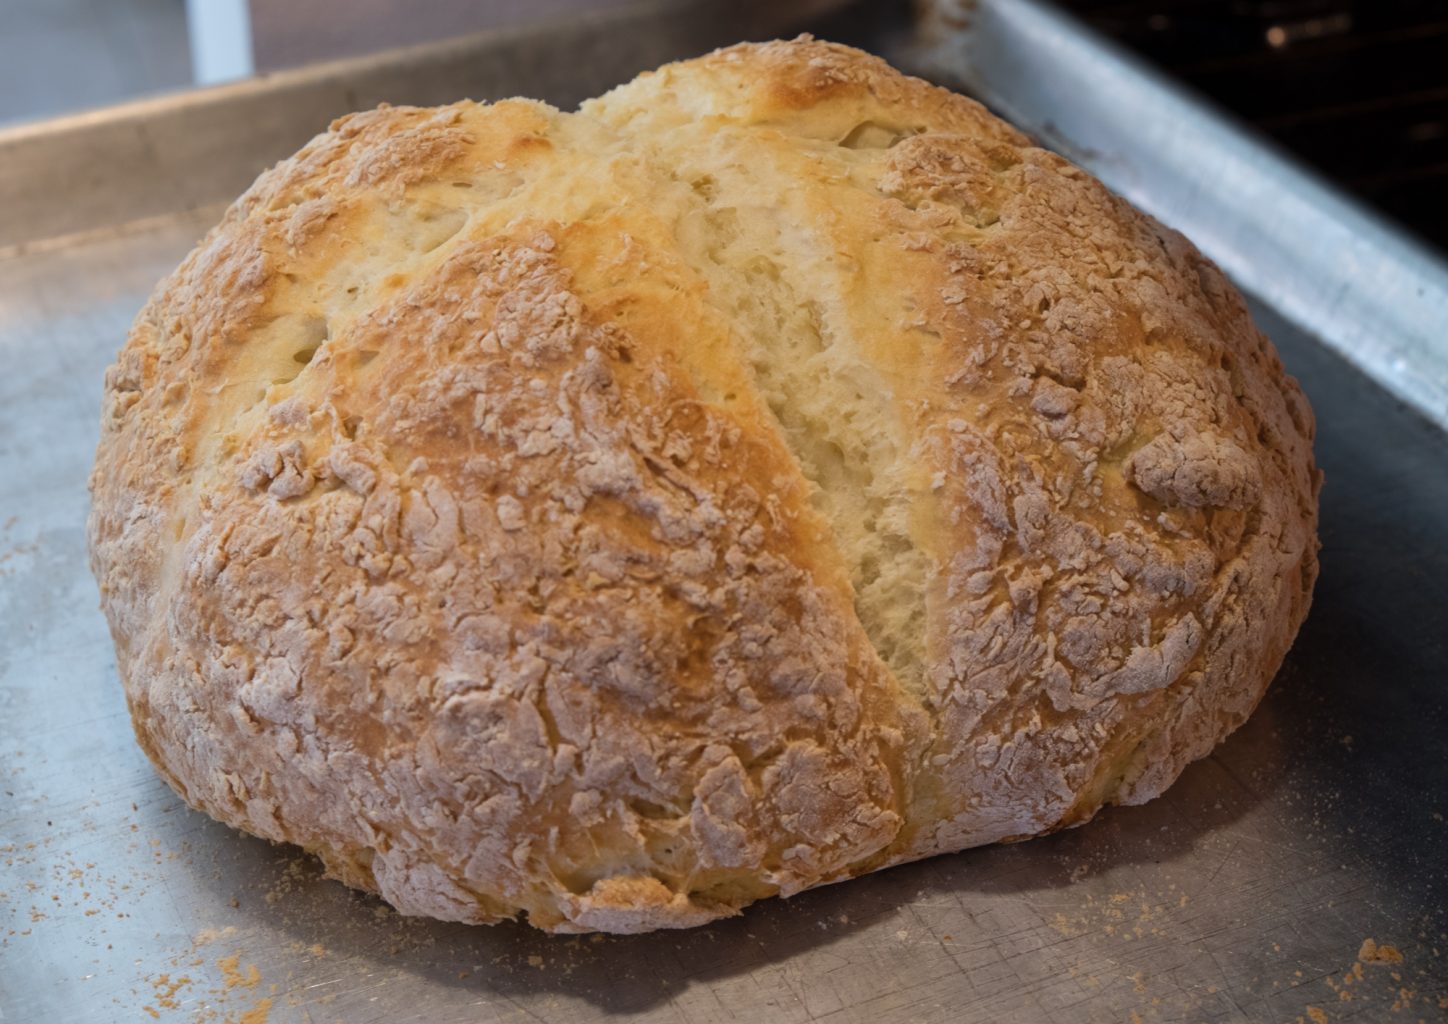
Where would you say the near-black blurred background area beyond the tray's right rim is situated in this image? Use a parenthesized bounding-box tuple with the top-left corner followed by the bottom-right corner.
(1057, 0, 1448, 249)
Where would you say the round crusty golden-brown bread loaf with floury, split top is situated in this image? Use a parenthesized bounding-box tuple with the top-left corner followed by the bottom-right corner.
(90, 38, 1319, 933)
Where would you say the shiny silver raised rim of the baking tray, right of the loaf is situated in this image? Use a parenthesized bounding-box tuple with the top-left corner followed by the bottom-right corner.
(922, 0, 1448, 426)
